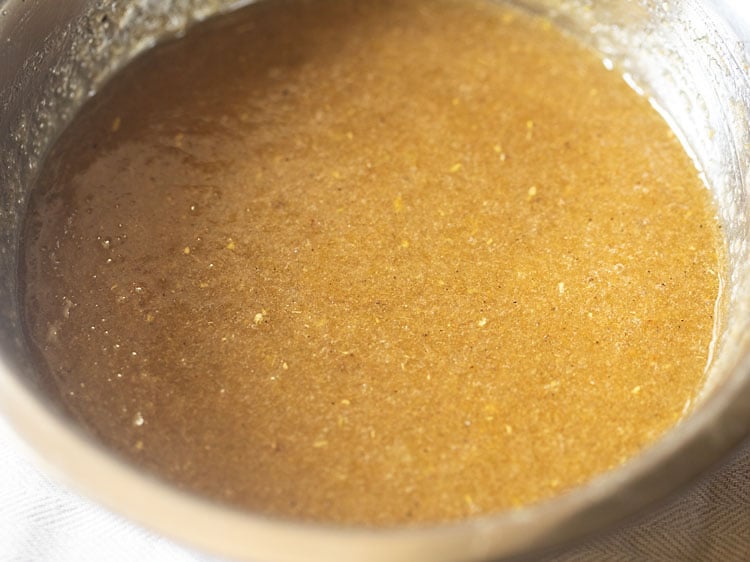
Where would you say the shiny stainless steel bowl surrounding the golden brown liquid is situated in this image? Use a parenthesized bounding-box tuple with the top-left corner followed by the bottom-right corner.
(0, 0, 750, 561)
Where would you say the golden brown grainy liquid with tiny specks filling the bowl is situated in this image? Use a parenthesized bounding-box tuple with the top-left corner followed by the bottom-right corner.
(25, 0, 721, 525)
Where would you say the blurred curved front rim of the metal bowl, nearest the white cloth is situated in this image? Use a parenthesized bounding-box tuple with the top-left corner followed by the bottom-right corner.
(0, 0, 750, 561)
